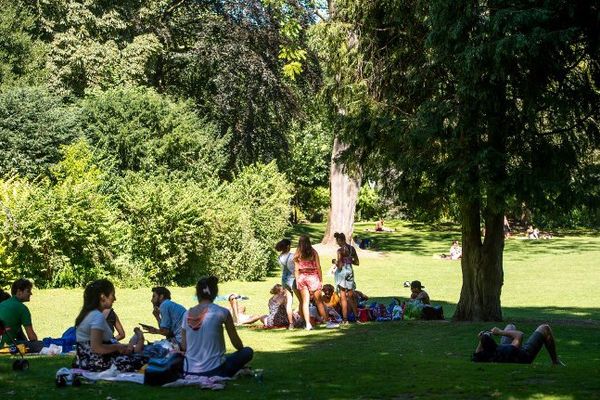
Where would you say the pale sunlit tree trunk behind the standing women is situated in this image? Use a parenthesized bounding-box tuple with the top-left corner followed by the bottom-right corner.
(321, 137, 361, 244)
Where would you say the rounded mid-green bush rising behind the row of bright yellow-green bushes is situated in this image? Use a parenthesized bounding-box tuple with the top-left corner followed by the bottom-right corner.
(81, 87, 227, 180)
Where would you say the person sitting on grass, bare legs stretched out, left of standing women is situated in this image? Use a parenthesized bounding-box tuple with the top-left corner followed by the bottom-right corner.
(229, 284, 294, 329)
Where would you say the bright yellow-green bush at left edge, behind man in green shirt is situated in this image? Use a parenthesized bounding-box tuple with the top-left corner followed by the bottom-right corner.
(0, 141, 122, 287)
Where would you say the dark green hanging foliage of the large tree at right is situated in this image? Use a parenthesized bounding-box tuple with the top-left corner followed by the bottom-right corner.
(314, 0, 600, 228)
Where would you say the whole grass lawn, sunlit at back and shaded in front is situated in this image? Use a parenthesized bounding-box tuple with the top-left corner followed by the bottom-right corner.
(0, 221, 600, 400)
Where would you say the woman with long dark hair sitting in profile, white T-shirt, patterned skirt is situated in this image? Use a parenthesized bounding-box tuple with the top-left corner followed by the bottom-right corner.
(75, 279, 145, 372)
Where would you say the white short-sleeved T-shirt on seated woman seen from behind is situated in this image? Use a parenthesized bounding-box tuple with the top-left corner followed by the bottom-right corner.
(182, 303, 229, 373)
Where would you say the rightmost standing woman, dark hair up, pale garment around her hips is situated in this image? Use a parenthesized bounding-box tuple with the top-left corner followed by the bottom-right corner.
(333, 232, 359, 324)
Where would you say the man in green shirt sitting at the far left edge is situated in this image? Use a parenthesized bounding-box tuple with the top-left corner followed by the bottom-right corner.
(0, 279, 42, 352)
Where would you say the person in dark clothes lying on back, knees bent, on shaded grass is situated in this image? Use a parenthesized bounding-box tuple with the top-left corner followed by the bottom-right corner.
(472, 324, 564, 365)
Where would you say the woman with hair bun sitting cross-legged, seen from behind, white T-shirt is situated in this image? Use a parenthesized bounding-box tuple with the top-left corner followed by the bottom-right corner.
(181, 276, 254, 377)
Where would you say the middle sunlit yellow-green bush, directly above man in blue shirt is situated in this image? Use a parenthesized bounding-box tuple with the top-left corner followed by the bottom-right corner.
(120, 173, 214, 285)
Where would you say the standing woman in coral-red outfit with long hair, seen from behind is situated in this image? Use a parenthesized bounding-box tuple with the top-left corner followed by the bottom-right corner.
(294, 235, 327, 330)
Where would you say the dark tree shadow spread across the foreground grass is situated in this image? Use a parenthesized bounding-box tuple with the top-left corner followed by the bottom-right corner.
(0, 304, 600, 400)
